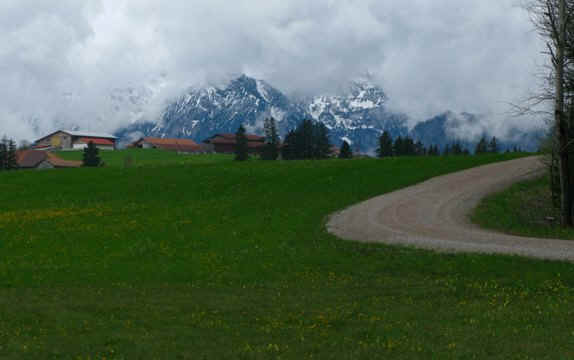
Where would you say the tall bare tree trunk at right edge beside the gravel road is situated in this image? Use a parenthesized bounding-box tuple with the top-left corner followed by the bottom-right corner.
(554, 0, 572, 226)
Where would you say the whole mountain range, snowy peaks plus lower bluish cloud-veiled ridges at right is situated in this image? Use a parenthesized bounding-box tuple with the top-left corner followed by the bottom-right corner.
(116, 75, 544, 154)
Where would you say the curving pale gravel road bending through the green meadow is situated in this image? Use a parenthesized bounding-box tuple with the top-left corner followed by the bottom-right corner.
(327, 157, 574, 260)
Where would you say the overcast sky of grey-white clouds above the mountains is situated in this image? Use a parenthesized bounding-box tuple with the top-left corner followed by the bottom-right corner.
(0, 0, 545, 139)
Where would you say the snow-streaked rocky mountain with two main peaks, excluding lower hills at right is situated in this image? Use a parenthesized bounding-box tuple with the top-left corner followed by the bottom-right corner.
(117, 75, 408, 151)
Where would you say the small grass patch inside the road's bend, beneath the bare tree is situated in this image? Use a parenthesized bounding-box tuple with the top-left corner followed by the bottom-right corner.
(472, 176, 574, 240)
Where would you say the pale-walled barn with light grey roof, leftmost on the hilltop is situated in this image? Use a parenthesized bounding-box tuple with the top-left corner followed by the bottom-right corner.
(33, 130, 117, 150)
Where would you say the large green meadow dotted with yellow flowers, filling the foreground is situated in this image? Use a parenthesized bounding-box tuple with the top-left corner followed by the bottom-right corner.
(0, 155, 574, 359)
